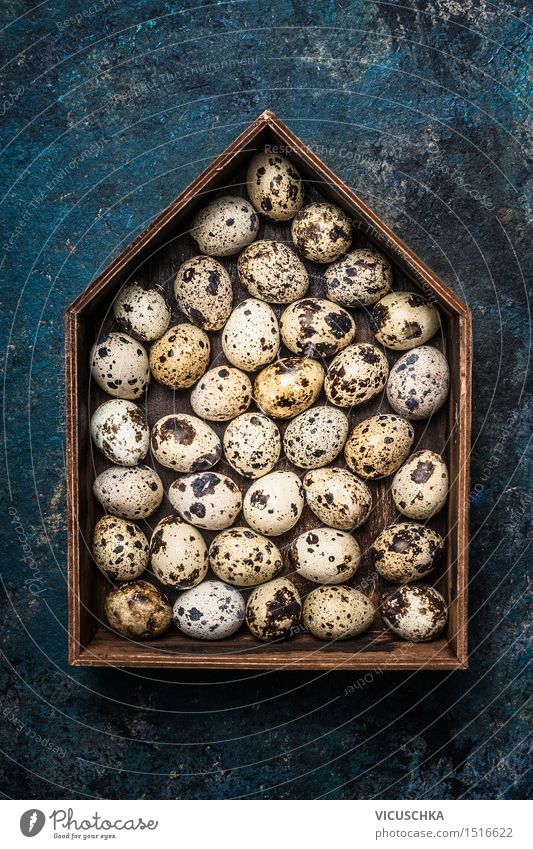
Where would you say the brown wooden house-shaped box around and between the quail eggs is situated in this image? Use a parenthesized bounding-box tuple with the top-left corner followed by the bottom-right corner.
(65, 111, 471, 670)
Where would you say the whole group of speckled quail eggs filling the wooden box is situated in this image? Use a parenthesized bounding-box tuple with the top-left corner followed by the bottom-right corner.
(90, 152, 449, 642)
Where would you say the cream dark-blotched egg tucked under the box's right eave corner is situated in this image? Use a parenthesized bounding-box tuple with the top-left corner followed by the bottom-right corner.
(372, 292, 440, 351)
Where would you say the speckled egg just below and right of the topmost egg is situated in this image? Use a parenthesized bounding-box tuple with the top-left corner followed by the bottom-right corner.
(291, 203, 352, 262)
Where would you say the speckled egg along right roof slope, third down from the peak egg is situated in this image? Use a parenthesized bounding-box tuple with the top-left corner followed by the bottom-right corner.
(324, 248, 392, 307)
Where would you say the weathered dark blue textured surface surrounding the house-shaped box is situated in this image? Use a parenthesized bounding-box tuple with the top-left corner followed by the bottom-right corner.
(0, 0, 533, 798)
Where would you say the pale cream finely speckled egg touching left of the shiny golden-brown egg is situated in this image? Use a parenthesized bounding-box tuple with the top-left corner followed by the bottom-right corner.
(191, 366, 252, 422)
